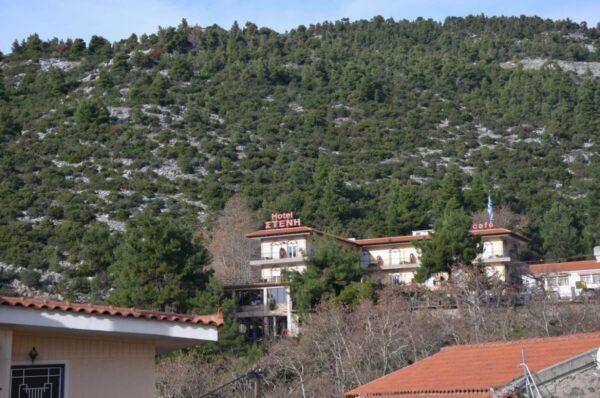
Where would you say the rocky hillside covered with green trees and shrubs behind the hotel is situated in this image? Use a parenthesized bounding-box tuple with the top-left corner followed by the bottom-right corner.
(0, 17, 600, 298)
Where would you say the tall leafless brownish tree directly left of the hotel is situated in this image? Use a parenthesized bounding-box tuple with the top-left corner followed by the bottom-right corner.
(208, 195, 258, 284)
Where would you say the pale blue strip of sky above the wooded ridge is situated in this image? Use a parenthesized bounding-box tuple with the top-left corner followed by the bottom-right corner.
(0, 0, 600, 53)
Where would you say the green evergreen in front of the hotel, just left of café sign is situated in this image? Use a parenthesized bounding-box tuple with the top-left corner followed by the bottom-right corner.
(415, 198, 480, 282)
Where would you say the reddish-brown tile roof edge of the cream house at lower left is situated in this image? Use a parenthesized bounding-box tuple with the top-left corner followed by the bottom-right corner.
(0, 296, 223, 326)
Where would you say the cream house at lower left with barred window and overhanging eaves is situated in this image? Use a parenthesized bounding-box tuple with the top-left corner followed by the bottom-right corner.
(0, 296, 223, 398)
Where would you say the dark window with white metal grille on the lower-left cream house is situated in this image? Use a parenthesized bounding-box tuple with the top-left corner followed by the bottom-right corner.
(10, 365, 65, 398)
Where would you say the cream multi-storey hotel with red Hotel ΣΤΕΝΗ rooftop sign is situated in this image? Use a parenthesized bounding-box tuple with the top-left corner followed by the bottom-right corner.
(226, 212, 527, 339)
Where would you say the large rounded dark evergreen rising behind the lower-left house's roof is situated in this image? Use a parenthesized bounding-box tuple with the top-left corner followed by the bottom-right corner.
(109, 215, 210, 312)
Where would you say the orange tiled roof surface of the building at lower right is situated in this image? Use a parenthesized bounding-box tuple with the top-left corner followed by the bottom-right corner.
(345, 333, 600, 398)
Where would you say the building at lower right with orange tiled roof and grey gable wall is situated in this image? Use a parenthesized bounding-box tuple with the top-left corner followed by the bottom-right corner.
(344, 333, 600, 398)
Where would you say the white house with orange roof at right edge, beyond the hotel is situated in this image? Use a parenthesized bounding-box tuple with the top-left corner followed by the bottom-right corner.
(524, 247, 600, 299)
